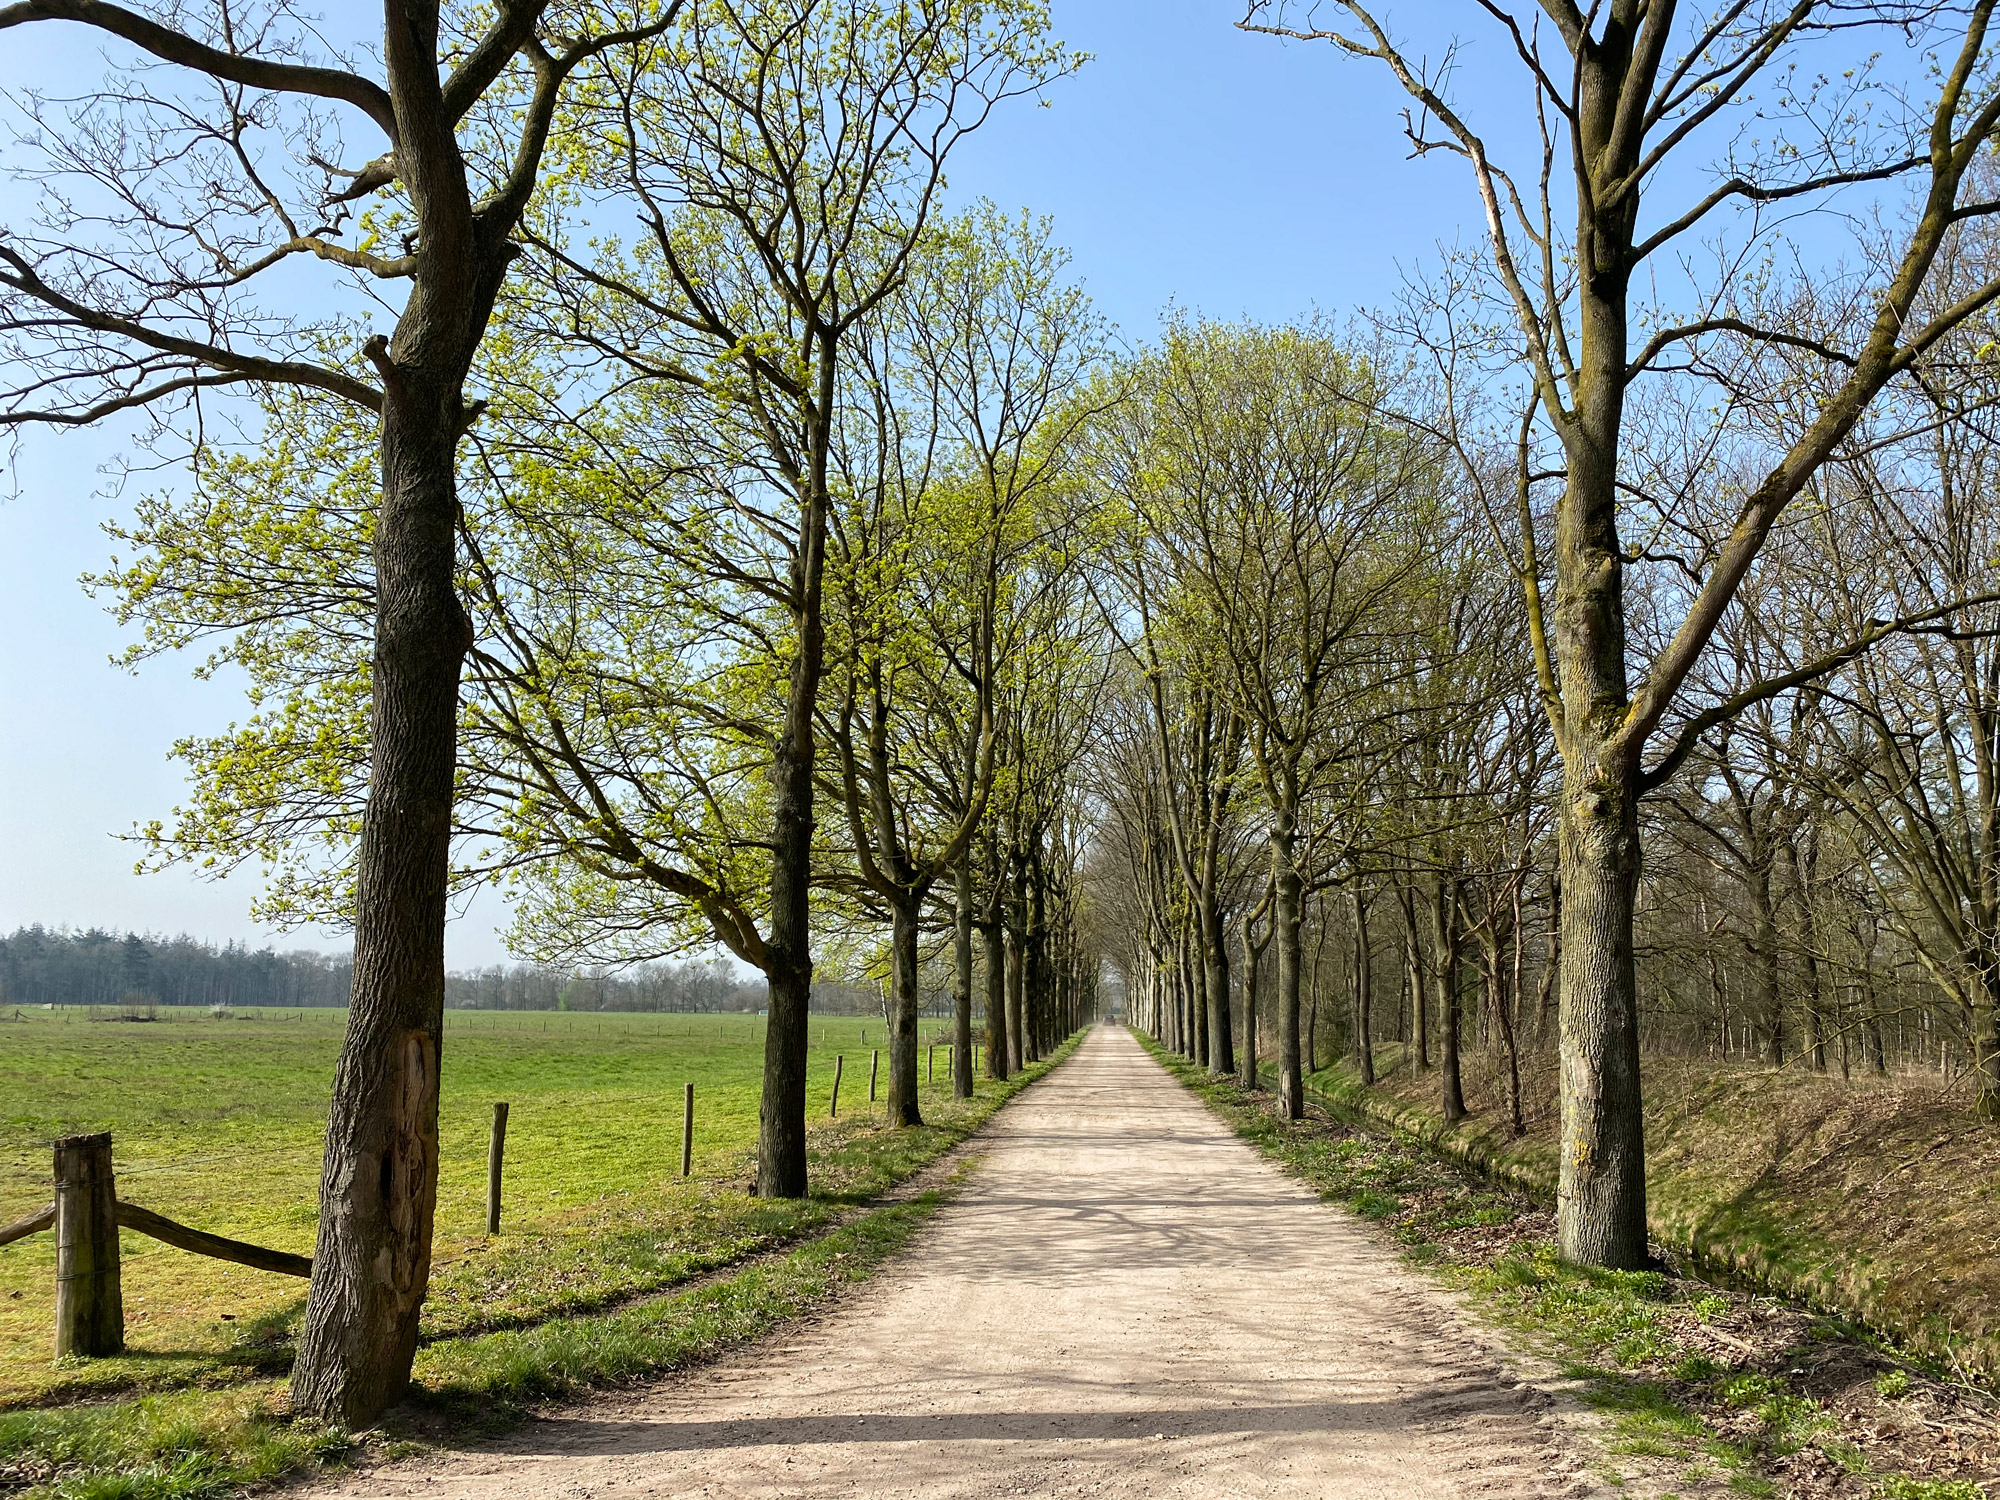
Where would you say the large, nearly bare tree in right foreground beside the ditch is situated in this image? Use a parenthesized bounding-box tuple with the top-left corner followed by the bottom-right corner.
(1242, 0, 2000, 1268)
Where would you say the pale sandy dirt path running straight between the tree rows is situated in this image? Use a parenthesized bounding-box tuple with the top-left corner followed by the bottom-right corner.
(320, 1028, 1590, 1500)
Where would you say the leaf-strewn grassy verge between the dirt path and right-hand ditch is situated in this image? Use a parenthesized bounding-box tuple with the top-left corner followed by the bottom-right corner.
(1148, 1042, 2000, 1500)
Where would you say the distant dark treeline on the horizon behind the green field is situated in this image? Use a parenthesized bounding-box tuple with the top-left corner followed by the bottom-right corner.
(0, 926, 882, 1014)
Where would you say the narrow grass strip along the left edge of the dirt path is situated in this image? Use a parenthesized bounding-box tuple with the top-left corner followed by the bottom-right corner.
(0, 1034, 1080, 1500)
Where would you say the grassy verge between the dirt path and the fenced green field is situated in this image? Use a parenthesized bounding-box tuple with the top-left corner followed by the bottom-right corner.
(0, 1042, 1074, 1500)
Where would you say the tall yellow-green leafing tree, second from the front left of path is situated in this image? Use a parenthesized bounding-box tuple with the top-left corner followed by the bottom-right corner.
(90, 0, 1074, 1196)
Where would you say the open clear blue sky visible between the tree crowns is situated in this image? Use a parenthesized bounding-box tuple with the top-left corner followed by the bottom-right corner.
(0, 0, 1512, 968)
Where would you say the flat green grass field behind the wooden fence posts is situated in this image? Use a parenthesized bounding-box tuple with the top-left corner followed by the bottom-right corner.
(0, 1008, 976, 1408)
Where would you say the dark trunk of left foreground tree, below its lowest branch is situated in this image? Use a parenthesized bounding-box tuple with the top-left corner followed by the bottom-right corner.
(292, 370, 472, 1428)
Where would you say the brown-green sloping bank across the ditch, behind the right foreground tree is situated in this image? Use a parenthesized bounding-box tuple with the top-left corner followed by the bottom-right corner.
(1308, 1044, 2000, 1376)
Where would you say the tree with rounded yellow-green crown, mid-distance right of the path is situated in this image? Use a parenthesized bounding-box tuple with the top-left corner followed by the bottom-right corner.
(1112, 322, 1438, 1120)
